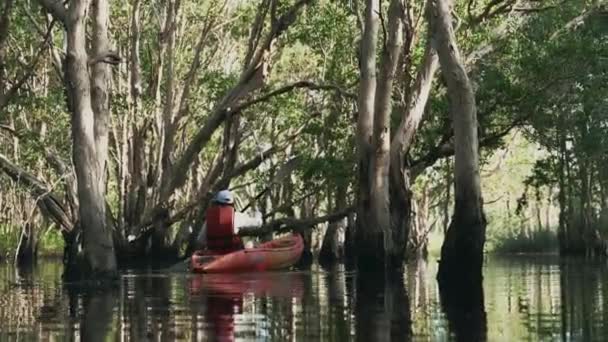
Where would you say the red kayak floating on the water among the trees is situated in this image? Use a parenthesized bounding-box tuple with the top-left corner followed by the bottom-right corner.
(190, 234, 304, 273)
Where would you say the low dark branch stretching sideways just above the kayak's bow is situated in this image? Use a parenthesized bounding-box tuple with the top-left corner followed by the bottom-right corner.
(239, 207, 355, 236)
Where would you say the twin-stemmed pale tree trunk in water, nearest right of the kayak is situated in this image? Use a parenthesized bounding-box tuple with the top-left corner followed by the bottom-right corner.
(356, 0, 403, 269)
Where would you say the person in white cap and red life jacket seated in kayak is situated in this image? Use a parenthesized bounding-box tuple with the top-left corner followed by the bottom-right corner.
(196, 190, 262, 255)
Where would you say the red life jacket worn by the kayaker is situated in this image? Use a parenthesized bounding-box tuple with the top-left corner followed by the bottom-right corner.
(205, 205, 244, 254)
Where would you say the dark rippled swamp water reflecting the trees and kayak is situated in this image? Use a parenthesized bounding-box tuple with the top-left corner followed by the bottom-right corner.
(0, 257, 608, 341)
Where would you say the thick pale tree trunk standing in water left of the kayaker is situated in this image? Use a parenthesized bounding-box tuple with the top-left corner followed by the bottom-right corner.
(66, 0, 116, 278)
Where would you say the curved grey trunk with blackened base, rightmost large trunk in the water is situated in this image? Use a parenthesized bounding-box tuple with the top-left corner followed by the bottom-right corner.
(429, 0, 486, 284)
